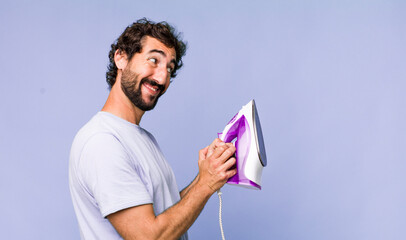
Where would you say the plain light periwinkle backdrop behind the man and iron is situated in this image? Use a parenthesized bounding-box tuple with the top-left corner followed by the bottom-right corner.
(0, 0, 406, 240)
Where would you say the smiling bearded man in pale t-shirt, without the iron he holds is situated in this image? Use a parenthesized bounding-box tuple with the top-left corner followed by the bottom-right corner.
(69, 19, 236, 239)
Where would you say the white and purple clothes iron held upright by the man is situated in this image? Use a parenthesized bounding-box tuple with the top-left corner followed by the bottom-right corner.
(218, 100, 267, 189)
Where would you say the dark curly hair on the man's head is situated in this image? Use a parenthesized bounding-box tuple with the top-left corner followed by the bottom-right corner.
(106, 18, 186, 88)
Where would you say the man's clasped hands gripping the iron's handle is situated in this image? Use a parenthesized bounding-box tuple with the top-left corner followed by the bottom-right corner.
(198, 138, 237, 193)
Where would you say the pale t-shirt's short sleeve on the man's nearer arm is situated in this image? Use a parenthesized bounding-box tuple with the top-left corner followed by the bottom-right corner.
(79, 133, 153, 217)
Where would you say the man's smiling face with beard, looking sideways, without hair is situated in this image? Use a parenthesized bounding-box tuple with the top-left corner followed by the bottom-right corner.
(121, 36, 176, 111)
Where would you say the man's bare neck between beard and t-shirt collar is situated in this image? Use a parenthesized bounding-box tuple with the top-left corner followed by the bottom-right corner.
(102, 83, 145, 125)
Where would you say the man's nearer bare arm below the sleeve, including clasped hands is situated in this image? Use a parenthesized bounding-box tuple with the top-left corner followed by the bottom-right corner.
(107, 139, 236, 239)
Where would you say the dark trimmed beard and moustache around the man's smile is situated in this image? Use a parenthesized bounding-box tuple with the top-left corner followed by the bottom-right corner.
(121, 68, 165, 111)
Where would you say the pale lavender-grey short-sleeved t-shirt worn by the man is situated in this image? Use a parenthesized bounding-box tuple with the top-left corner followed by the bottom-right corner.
(69, 112, 187, 240)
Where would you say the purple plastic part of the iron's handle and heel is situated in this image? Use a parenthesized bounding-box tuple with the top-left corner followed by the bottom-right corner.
(218, 115, 261, 189)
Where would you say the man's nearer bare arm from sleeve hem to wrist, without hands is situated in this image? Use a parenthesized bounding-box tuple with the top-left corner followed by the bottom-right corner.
(107, 182, 214, 240)
